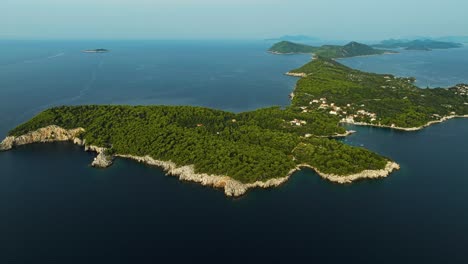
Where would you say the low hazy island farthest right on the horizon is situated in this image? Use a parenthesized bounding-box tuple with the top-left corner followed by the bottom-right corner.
(372, 39, 463, 51)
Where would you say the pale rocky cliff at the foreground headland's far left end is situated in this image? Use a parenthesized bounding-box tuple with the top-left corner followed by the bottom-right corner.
(0, 125, 84, 150)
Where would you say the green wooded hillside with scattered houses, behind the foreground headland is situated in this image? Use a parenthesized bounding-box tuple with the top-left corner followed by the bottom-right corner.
(291, 57, 468, 128)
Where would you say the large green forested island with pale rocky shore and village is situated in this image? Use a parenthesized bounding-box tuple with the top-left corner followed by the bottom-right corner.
(0, 46, 468, 196)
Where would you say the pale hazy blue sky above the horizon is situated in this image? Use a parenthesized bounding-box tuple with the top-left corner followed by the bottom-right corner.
(0, 0, 468, 40)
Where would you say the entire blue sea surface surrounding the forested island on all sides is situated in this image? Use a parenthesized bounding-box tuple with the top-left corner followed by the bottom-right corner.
(0, 41, 468, 263)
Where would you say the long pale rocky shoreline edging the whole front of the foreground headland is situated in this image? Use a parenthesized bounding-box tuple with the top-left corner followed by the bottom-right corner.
(0, 125, 400, 197)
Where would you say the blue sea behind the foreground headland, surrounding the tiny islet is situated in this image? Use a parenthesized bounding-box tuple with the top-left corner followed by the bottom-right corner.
(0, 41, 310, 135)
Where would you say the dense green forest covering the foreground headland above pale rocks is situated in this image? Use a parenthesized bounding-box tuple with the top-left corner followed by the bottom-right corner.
(10, 105, 387, 182)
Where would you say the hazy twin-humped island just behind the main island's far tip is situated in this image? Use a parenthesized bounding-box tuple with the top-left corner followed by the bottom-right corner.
(268, 41, 396, 58)
